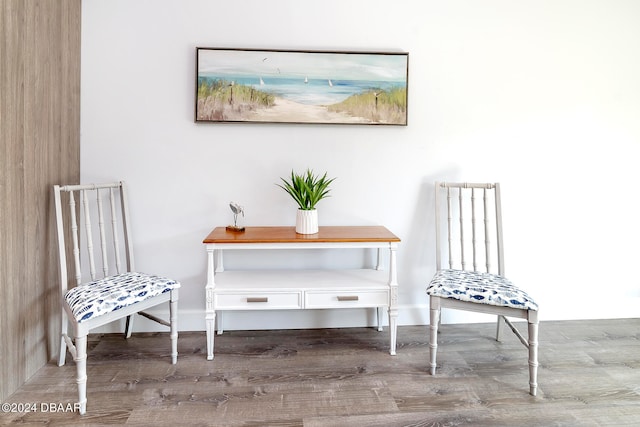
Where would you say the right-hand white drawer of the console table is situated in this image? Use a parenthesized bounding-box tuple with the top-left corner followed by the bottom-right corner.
(305, 289, 389, 308)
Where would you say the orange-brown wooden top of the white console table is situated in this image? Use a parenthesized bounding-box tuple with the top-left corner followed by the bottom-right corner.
(202, 225, 400, 244)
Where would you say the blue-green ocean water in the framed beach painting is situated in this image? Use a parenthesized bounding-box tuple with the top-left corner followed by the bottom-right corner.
(198, 72, 406, 105)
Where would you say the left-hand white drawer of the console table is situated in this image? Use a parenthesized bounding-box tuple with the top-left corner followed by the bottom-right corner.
(214, 291, 302, 310)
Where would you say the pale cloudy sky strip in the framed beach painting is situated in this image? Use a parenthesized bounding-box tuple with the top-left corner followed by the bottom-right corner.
(198, 49, 407, 81)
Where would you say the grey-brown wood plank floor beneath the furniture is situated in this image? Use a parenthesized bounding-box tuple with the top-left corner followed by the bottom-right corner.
(0, 319, 640, 427)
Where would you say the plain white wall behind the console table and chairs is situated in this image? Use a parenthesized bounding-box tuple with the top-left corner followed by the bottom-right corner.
(81, 0, 640, 330)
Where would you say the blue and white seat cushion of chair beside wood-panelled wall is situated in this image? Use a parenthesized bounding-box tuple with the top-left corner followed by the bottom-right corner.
(64, 272, 180, 323)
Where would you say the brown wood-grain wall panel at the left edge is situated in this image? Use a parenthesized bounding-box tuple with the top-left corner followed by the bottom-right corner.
(0, 0, 81, 401)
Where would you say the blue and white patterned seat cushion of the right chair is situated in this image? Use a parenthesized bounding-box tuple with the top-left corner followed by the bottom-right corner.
(427, 269, 538, 310)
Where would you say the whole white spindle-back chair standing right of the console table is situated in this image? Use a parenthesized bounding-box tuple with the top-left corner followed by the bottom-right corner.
(427, 182, 538, 396)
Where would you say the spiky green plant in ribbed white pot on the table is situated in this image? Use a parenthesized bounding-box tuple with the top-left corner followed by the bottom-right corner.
(276, 169, 335, 234)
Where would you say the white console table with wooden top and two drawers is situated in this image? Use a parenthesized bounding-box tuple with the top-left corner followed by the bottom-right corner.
(203, 226, 400, 360)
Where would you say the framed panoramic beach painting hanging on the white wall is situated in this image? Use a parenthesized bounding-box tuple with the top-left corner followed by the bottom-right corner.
(195, 47, 409, 126)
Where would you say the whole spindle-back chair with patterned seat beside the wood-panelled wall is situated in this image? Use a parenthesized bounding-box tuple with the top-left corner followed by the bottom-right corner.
(54, 182, 180, 414)
